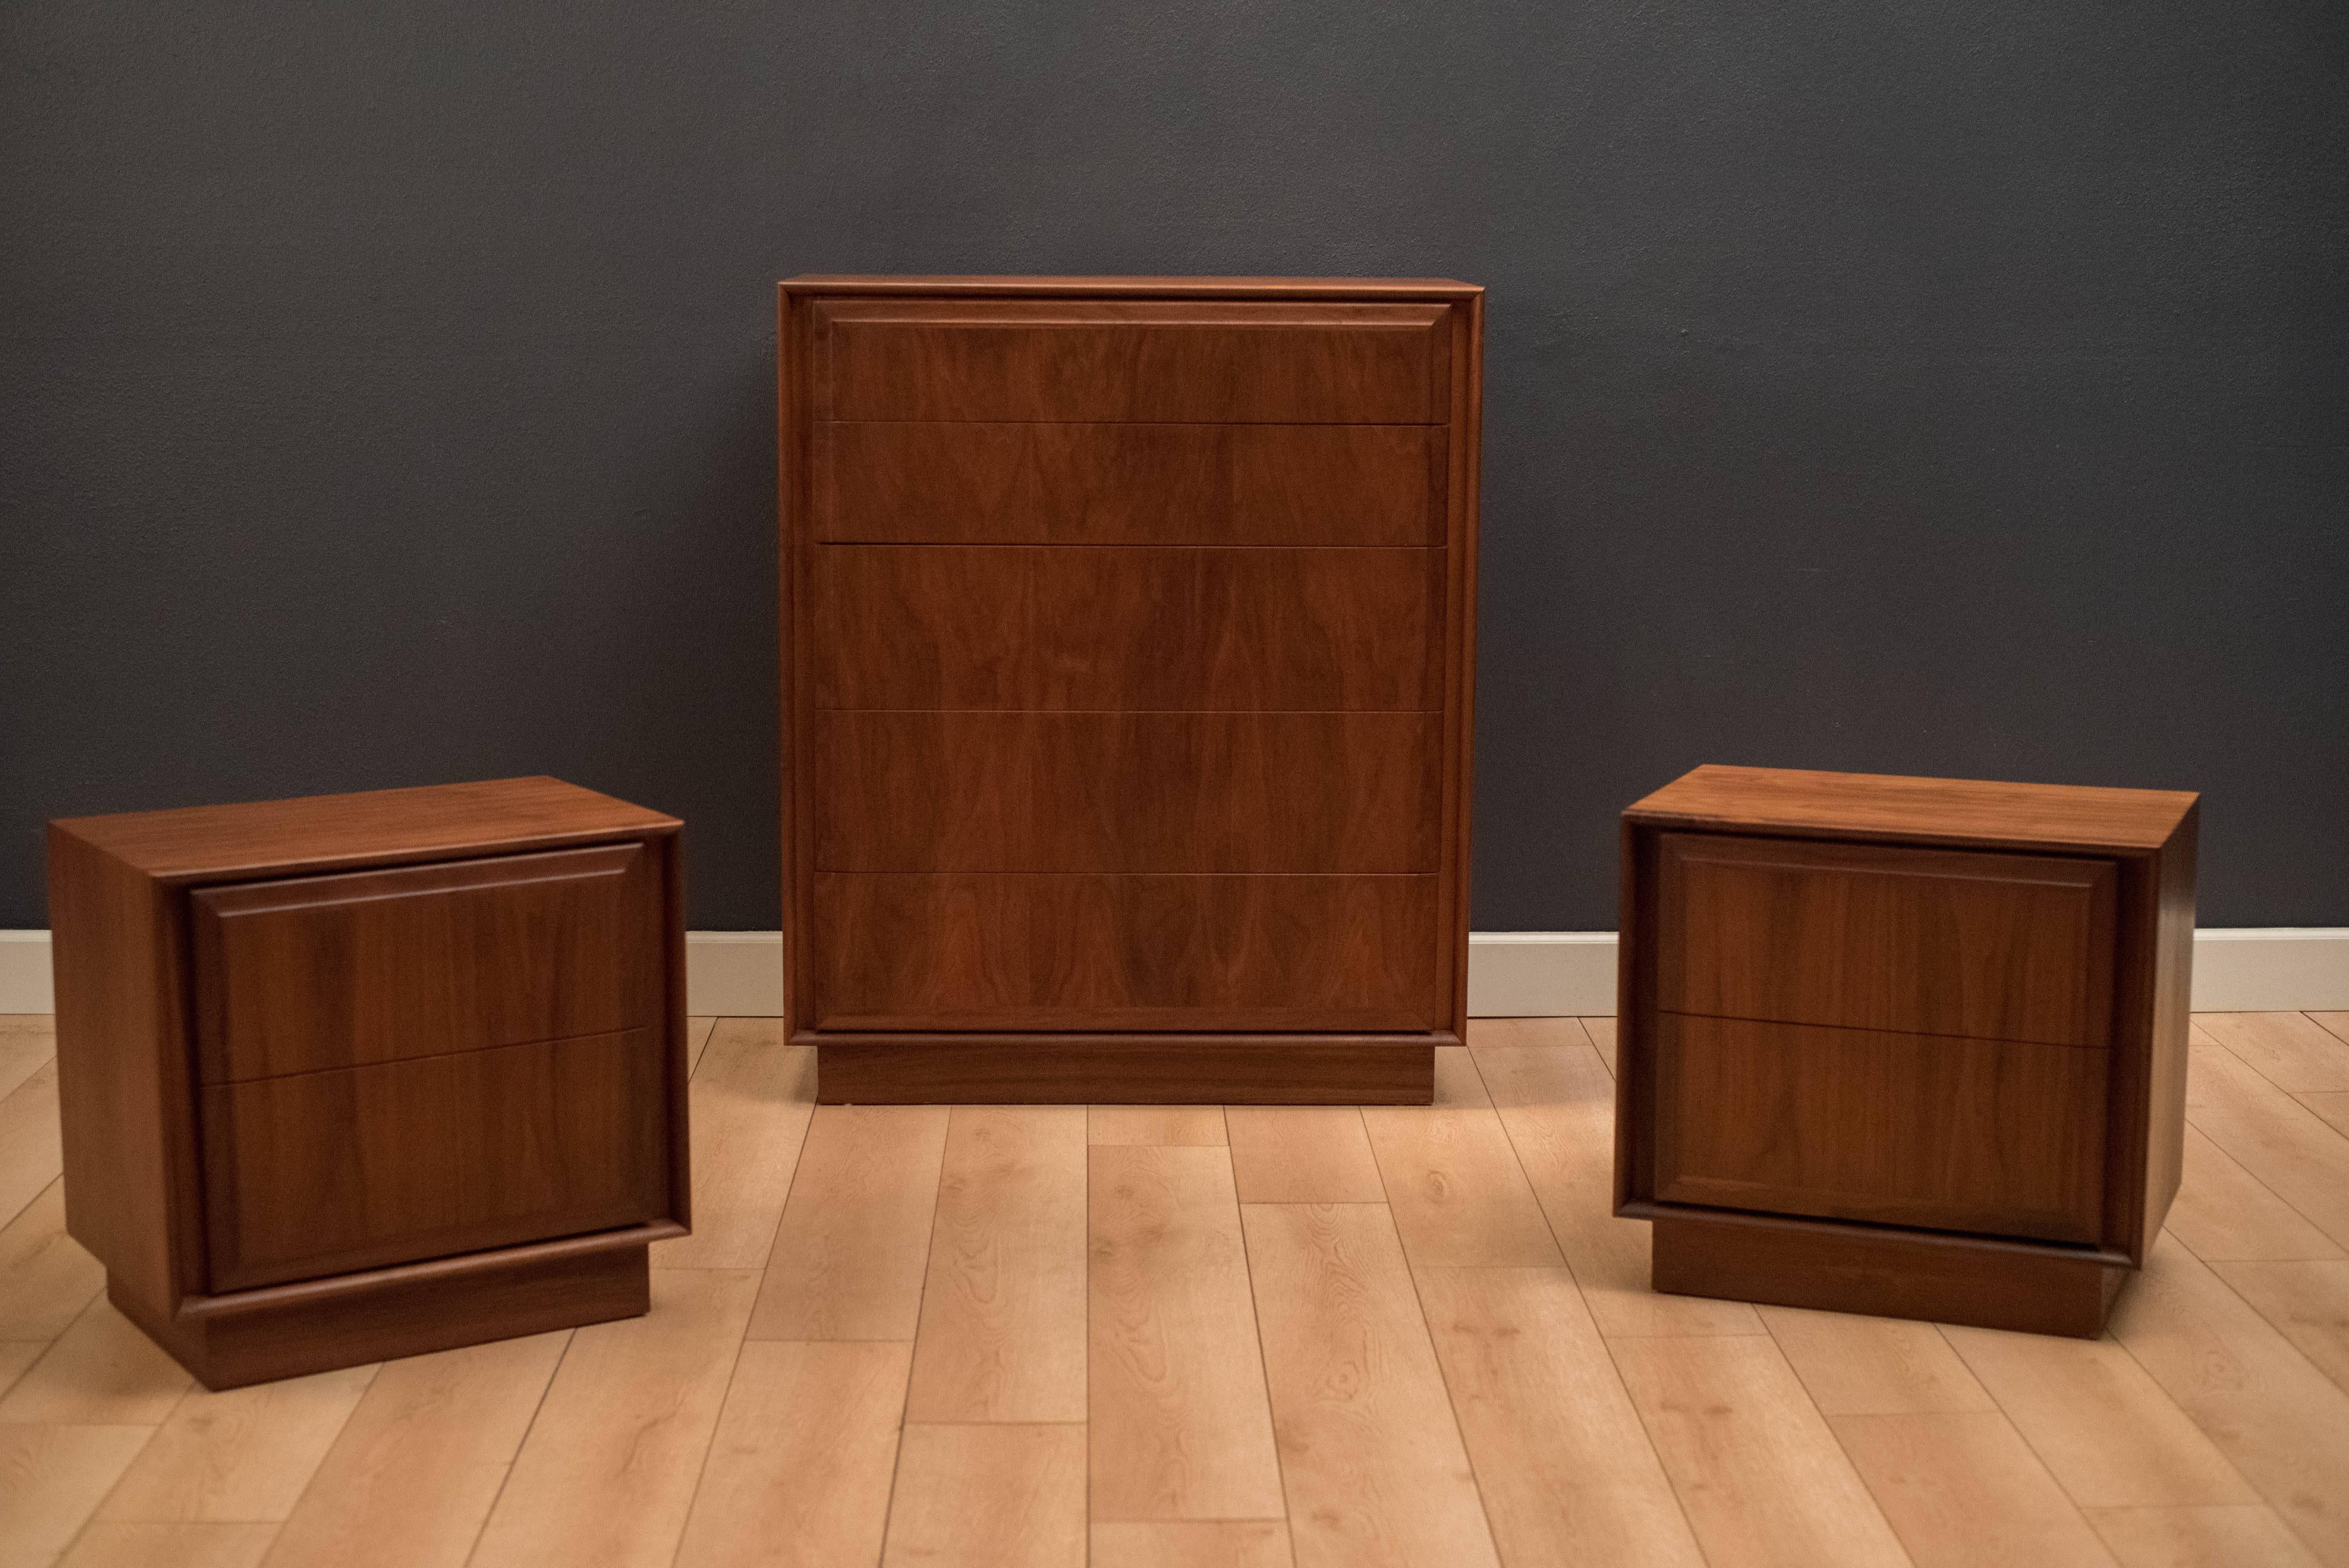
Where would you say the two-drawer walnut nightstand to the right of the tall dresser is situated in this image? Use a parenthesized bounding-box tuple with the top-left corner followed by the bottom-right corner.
(1616, 768, 2196, 1336)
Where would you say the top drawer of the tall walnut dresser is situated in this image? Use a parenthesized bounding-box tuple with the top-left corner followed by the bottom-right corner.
(808, 300, 1452, 425)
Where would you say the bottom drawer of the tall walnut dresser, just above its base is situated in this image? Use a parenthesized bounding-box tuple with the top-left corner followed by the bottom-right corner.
(806, 873, 1449, 1030)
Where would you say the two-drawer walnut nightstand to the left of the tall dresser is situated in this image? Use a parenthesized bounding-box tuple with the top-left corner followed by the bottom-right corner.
(49, 779, 688, 1387)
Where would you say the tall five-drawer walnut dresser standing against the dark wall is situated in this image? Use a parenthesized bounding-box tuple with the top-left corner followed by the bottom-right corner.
(780, 277, 1482, 1103)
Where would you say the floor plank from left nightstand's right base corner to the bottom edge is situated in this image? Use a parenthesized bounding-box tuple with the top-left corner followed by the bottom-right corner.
(470, 1268, 759, 1568)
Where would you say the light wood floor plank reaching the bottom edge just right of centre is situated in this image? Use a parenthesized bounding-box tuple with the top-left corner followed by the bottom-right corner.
(1240, 1204, 1501, 1568)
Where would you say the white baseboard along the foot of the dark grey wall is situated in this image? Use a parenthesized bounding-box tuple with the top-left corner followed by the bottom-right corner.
(0, 925, 2349, 1019)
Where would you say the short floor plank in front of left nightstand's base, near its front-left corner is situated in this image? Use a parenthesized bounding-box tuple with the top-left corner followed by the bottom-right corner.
(99, 1364, 376, 1524)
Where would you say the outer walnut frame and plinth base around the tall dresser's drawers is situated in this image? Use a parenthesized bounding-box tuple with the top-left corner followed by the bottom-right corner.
(778, 277, 1484, 1103)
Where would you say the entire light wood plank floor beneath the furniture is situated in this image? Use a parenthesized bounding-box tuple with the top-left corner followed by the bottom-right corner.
(0, 1014, 2349, 1568)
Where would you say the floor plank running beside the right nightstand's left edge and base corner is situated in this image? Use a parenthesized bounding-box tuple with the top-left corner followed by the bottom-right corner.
(1475, 1047, 1762, 1338)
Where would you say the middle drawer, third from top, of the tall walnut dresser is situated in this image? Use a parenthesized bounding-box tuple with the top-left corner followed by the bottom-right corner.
(813, 545, 1445, 711)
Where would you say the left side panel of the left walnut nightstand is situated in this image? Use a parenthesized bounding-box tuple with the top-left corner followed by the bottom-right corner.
(49, 826, 195, 1312)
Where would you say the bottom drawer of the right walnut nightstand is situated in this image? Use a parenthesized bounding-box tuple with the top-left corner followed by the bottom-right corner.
(1654, 1012, 2105, 1242)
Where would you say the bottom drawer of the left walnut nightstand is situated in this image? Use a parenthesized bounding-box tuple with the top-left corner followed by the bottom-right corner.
(202, 1028, 669, 1291)
